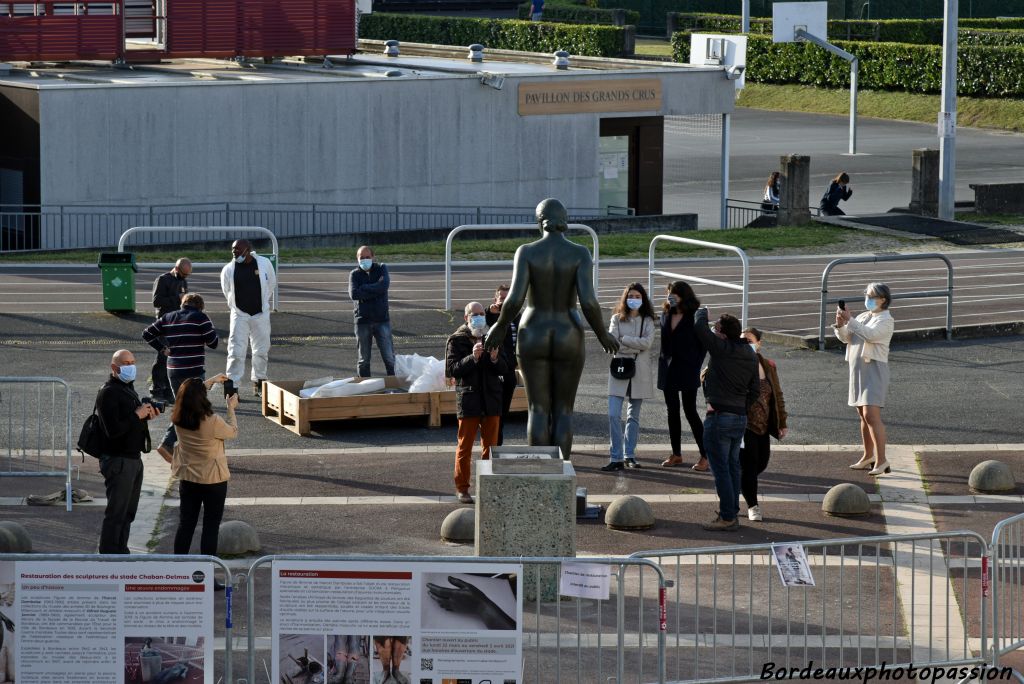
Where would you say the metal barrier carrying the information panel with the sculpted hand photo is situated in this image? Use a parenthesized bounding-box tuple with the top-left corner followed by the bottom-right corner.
(246, 555, 667, 684)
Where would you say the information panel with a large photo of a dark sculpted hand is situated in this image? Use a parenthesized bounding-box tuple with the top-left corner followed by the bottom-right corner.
(271, 561, 522, 684)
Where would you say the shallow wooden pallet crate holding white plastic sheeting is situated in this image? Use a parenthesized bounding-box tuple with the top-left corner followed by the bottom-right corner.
(262, 377, 526, 436)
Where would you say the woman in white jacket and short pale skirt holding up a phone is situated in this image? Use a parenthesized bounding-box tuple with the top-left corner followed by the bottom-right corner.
(835, 283, 896, 475)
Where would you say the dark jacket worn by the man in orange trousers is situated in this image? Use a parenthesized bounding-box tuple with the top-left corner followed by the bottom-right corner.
(444, 325, 510, 418)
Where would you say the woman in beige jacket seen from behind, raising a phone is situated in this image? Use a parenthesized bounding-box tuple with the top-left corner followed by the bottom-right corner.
(171, 375, 239, 556)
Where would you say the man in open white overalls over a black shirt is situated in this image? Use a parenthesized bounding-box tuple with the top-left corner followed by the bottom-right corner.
(220, 240, 278, 396)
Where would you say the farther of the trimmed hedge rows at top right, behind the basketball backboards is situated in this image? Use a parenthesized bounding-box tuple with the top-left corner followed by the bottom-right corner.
(669, 12, 1024, 45)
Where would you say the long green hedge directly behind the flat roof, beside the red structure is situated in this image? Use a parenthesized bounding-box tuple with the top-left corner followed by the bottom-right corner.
(359, 12, 626, 57)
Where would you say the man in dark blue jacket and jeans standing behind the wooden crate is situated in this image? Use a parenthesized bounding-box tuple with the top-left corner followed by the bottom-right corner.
(348, 245, 394, 378)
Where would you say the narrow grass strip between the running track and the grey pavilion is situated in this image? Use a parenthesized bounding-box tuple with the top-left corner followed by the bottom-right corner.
(0, 223, 853, 264)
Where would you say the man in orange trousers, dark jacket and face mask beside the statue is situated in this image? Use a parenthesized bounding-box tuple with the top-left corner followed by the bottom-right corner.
(444, 302, 509, 504)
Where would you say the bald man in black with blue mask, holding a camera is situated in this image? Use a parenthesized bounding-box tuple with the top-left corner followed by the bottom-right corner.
(96, 349, 160, 554)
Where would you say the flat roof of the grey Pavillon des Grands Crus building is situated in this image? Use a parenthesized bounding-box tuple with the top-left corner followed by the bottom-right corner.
(0, 41, 722, 89)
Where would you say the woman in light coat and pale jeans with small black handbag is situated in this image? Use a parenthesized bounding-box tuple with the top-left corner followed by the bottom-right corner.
(601, 283, 657, 472)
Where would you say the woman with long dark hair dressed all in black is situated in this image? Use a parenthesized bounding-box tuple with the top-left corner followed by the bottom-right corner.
(657, 281, 708, 472)
